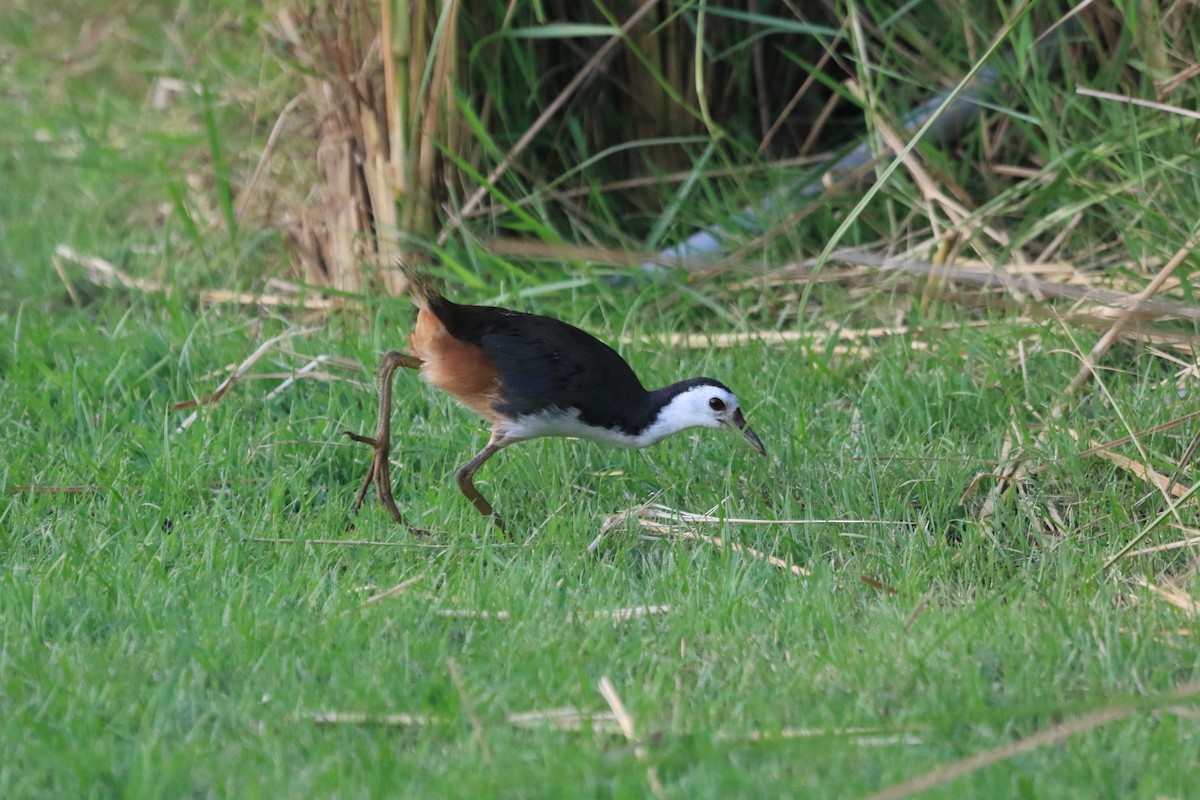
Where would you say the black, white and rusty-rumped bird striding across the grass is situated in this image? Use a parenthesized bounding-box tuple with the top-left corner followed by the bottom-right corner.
(346, 273, 767, 535)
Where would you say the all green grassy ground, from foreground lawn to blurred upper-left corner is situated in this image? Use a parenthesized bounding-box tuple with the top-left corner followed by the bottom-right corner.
(0, 1, 1200, 798)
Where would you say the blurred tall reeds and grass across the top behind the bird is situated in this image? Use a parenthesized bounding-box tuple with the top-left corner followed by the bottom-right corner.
(0, 0, 1200, 311)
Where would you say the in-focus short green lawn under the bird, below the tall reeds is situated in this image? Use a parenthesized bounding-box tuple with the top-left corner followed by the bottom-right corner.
(0, 286, 1200, 796)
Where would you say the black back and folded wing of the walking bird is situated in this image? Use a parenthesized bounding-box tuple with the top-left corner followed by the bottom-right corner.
(427, 293, 659, 434)
